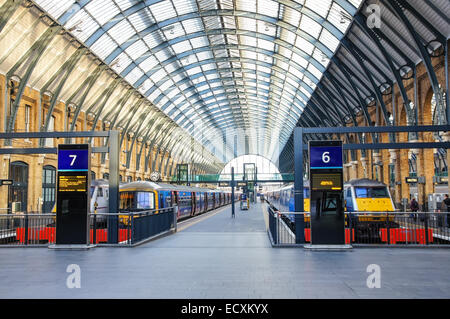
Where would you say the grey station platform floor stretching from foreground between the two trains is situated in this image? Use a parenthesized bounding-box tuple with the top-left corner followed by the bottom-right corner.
(0, 203, 450, 299)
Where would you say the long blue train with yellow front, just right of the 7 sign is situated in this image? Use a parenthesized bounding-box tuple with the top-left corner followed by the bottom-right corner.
(119, 181, 234, 224)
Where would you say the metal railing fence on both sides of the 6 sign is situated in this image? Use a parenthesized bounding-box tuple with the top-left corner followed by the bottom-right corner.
(268, 206, 450, 247)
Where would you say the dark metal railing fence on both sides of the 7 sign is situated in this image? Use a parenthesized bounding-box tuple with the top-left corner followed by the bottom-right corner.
(0, 207, 177, 247)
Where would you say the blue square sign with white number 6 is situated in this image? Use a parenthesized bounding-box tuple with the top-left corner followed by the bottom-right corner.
(309, 146, 342, 169)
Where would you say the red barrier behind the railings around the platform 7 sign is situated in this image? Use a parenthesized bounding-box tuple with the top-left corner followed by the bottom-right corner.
(16, 227, 128, 244)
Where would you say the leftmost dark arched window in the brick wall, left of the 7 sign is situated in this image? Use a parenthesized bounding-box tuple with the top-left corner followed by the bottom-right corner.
(8, 162, 28, 212)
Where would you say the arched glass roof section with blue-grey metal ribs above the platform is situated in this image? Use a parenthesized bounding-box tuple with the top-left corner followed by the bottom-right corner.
(35, 0, 362, 161)
